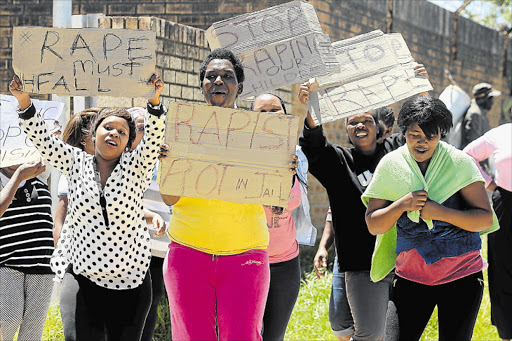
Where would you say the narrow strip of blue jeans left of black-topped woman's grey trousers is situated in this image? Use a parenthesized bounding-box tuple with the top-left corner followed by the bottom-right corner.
(329, 256, 354, 337)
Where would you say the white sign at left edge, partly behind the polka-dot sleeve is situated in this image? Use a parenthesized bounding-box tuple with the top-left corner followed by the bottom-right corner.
(0, 95, 64, 167)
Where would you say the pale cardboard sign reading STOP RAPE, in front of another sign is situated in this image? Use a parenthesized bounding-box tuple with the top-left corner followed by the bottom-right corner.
(308, 30, 432, 124)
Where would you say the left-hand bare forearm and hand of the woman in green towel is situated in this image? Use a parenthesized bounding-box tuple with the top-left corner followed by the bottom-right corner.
(365, 191, 427, 235)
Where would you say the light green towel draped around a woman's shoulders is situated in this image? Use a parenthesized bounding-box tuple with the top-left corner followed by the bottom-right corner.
(361, 141, 499, 282)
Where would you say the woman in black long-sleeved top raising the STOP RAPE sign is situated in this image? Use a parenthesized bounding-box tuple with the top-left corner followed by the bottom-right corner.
(299, 64, 428, 341)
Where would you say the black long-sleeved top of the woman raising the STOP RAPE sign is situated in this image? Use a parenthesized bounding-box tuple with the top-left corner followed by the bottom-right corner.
(299, 122, 405, 272)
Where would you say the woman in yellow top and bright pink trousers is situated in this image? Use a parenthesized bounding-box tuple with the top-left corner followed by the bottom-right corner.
(162, 49, 296, 340)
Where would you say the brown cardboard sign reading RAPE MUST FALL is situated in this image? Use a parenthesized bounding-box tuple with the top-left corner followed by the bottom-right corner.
(12, 27, 156, 98)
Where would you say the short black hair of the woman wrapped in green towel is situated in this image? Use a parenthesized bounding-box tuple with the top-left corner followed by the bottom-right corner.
(398, 95, 453, 138)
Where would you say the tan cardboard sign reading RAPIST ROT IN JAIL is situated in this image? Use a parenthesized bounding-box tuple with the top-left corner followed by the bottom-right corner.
(160, 102, 299, 207)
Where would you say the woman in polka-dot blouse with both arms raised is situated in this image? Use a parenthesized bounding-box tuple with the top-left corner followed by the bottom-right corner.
(9, 75, 165, 340)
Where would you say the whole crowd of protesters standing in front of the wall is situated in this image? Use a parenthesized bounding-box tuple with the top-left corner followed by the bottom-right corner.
(0, 23, 512, 340)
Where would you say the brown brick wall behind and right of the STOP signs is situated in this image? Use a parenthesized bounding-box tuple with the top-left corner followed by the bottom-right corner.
(293, 0, 512, 227)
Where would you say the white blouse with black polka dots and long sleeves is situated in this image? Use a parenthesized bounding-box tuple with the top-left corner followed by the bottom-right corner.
(20, 105, 166, 289)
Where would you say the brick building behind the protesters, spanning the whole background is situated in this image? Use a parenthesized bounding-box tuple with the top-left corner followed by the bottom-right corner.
(0, 0, 512, 227)
